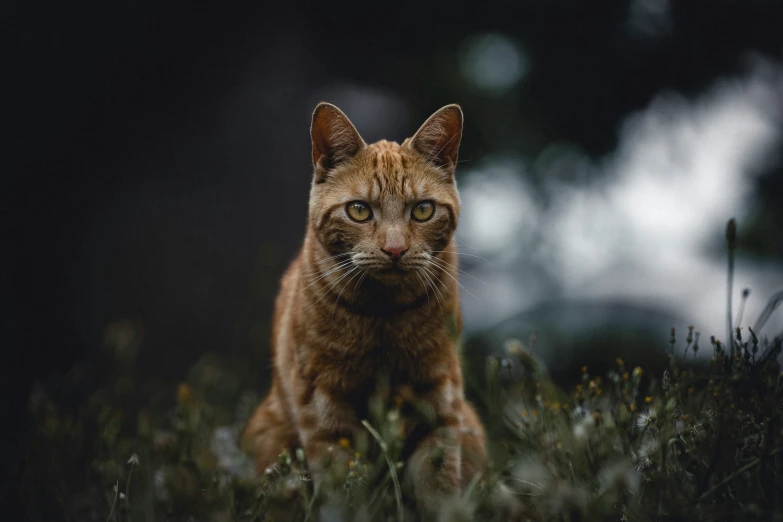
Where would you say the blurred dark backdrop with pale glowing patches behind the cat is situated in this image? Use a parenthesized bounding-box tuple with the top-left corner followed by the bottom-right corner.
(6, 0, 783, 512)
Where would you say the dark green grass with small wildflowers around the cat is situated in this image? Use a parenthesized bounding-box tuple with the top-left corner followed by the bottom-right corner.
(20, 220, 783, 522)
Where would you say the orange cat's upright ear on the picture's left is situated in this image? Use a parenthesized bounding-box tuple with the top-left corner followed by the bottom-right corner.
(310, 102, 367, 183)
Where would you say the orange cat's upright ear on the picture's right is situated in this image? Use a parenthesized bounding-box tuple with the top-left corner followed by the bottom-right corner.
(408, 104, 462, 175)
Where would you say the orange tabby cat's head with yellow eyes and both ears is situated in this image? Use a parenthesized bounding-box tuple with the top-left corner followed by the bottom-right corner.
(309, 103, 462, 283)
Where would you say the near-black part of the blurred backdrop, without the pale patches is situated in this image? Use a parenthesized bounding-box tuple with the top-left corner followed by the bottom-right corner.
(2, 0, 783, 516)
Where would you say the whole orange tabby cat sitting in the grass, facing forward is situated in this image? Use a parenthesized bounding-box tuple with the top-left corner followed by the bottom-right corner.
(243, 103, 486, 512)
